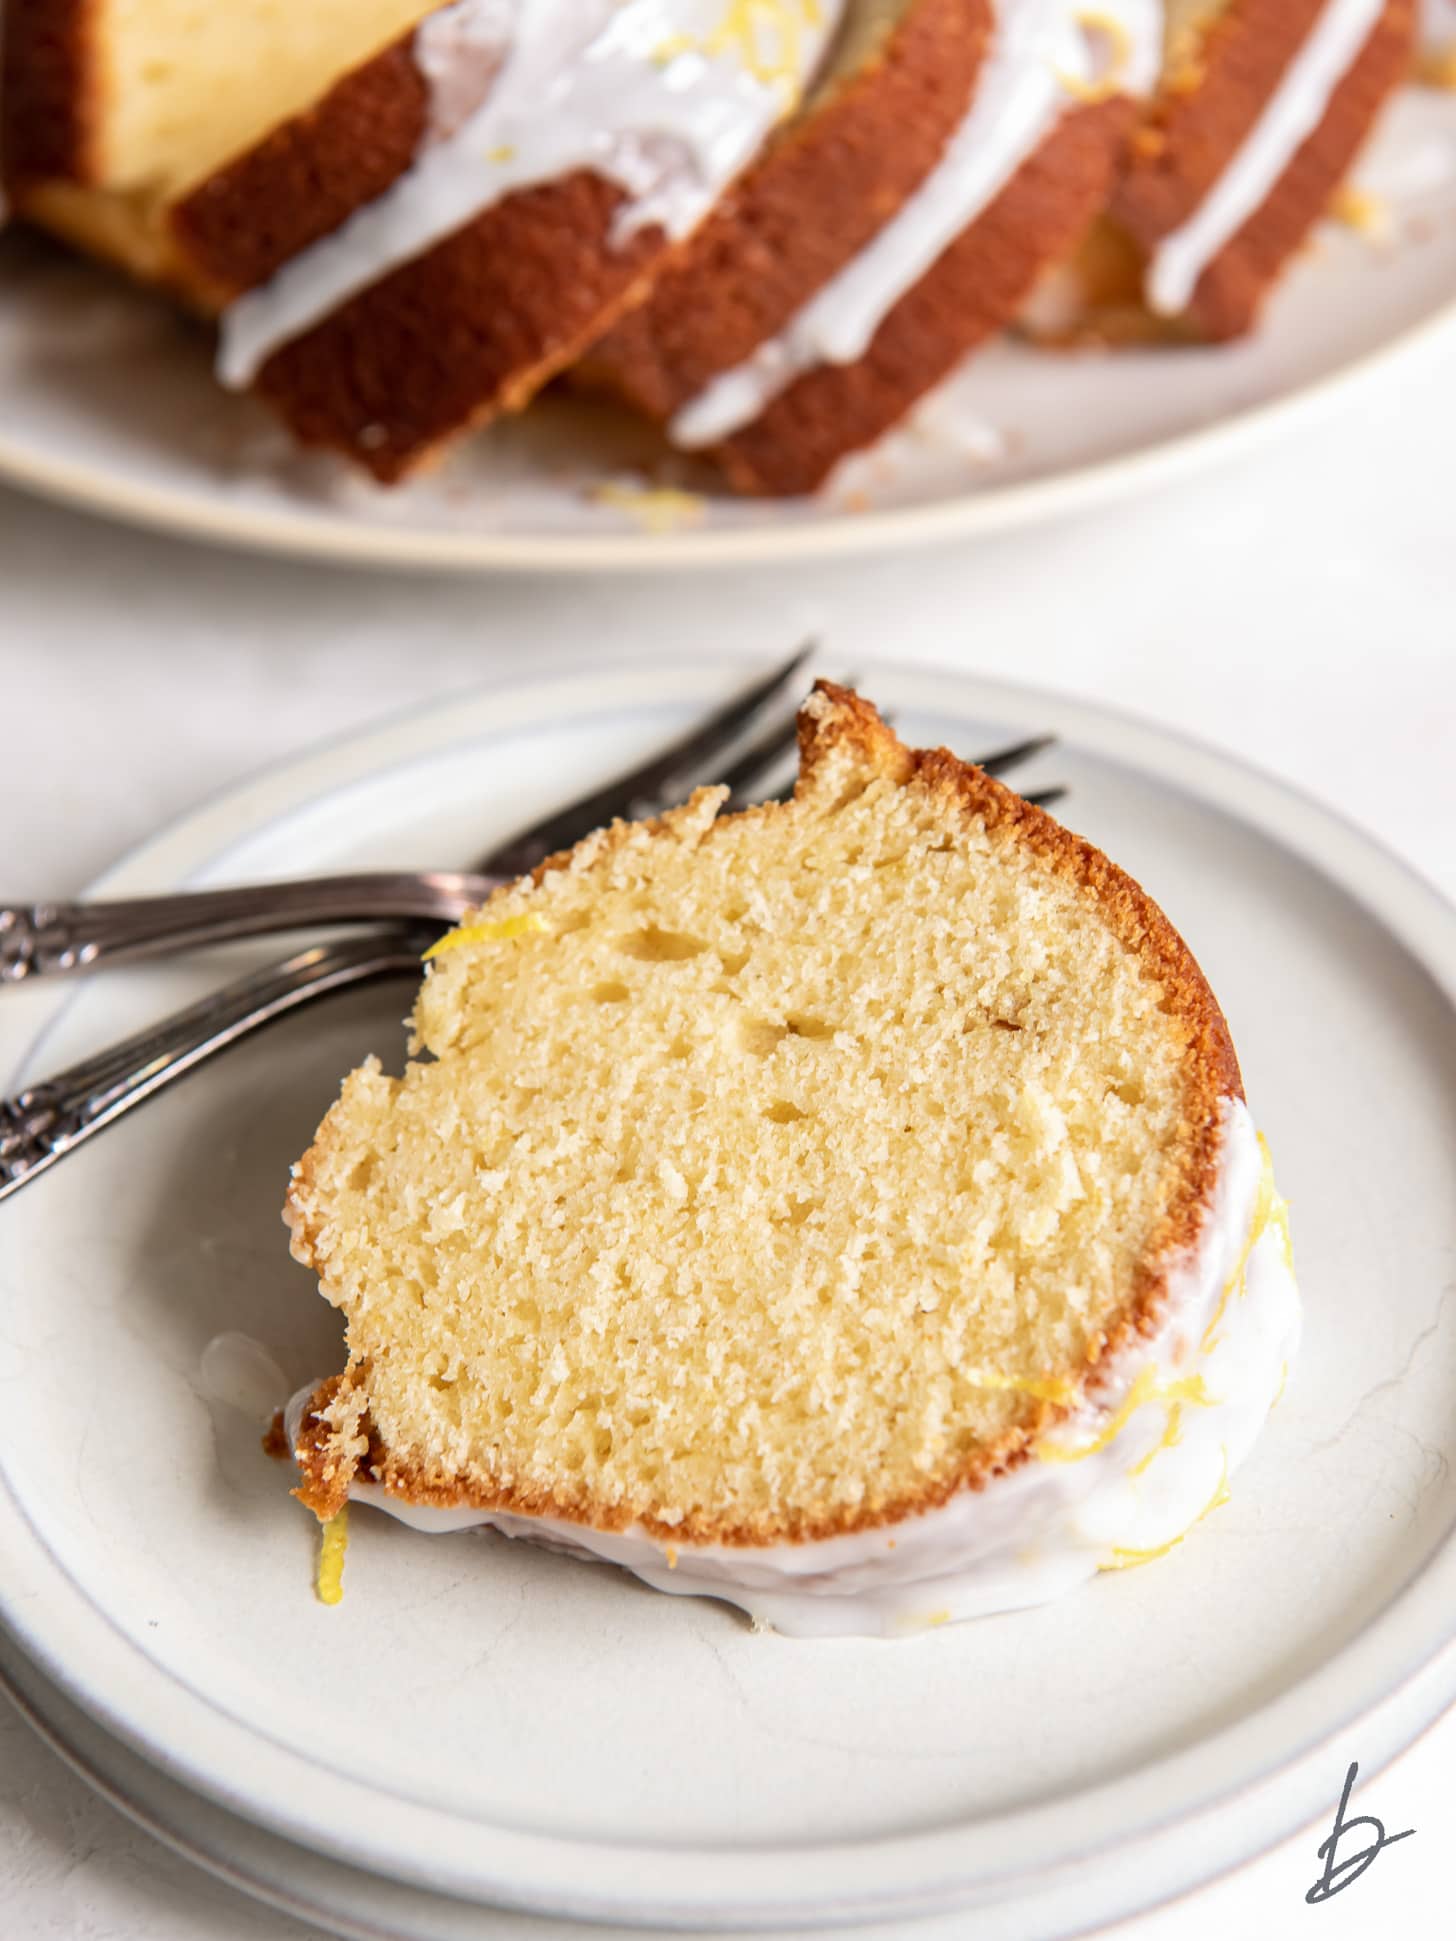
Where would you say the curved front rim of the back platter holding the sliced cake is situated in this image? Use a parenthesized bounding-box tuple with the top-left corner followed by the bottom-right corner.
(0, 277, 1456, 576)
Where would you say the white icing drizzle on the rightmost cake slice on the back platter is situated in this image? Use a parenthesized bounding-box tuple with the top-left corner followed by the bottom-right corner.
(1145, 0, 1384, 316)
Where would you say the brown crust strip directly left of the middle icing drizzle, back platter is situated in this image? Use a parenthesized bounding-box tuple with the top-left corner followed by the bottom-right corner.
(582, 0, 990, 419)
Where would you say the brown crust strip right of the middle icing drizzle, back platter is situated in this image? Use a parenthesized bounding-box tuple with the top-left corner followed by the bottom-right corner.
(712, 99, 1136, 497)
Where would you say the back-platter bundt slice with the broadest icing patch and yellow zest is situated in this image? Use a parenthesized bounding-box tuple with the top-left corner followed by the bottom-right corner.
(173, 0, 843, 479)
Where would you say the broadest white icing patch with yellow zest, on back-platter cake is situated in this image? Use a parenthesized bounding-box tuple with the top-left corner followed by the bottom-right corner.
(217, 0, 841, 386)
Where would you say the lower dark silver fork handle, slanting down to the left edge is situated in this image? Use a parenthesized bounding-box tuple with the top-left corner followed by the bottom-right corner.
(0, 930, 435, 1200)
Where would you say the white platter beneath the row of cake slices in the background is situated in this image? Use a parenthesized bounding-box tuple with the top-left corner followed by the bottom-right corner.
(0, 89, 1456, 571)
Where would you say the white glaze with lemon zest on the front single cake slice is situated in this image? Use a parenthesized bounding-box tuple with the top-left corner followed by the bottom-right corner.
(287, 1101, 1299, 1636)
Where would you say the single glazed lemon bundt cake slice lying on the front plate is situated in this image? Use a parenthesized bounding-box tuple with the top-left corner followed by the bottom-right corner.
(285, 685, 1299, 1634)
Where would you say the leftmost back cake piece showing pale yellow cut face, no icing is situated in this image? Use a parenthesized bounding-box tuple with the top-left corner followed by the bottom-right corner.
(0, 0, 433, 293)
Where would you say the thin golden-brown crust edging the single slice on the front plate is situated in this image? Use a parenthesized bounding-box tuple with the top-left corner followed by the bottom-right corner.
(287, 681, 1242, 1547)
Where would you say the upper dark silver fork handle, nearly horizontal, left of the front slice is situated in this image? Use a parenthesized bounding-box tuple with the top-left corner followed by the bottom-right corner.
(0, 870, 505, 984)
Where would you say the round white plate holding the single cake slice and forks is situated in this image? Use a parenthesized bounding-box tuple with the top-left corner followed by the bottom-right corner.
(0, 664, 1456, 1941)
